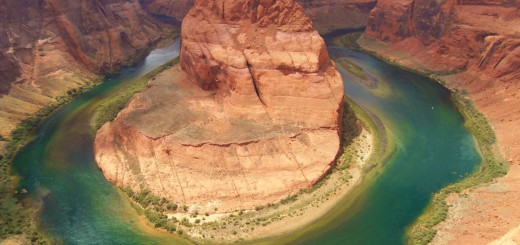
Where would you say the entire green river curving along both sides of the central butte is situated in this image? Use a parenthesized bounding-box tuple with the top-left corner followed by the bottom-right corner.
(12, 37, 481, 244)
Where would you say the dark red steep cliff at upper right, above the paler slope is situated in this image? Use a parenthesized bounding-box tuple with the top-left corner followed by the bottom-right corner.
(365, 0, 520, 77)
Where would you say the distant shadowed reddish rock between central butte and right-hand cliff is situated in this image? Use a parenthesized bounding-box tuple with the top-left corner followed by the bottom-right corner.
(298, 0, 377, 34)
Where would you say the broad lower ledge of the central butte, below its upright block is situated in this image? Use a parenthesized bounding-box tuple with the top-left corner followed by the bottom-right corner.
(95, 67, 339, 212)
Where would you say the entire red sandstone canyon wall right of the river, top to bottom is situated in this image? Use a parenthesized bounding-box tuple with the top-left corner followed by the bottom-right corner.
(358, 0, 520, 244)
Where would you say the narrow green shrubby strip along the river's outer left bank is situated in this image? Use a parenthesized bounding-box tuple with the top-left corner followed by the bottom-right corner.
(0, 31, 180, 243)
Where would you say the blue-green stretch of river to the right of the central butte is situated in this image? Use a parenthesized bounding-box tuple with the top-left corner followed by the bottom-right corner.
(274, 46, 481, 245)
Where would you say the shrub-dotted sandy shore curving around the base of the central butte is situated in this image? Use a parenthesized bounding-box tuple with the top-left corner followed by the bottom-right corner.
(118, 94, 386, 244)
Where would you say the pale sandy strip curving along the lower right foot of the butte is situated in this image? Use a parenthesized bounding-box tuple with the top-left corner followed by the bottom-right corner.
(152, 97, 377, 243)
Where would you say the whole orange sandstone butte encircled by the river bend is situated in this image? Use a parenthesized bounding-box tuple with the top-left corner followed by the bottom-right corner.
(95, 0, 343, 212)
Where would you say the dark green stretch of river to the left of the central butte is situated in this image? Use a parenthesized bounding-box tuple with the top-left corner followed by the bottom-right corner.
(12, 41, 189, 244)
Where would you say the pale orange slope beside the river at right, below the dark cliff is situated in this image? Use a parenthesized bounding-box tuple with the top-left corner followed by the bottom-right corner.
(358, 33, 520, 244)
